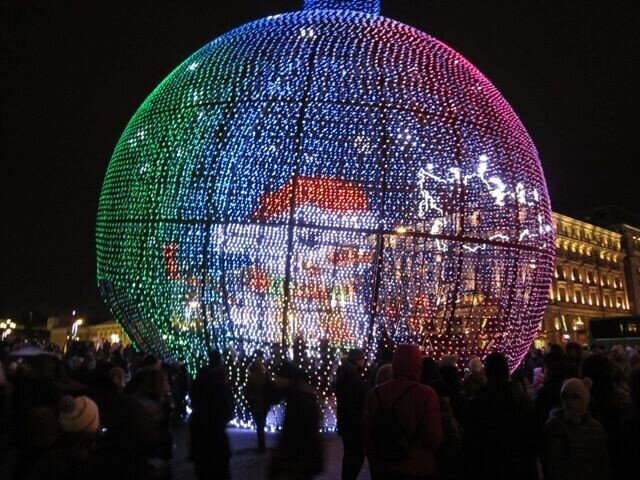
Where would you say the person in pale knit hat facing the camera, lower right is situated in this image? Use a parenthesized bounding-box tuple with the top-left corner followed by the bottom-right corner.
(542, 378, 611, 480)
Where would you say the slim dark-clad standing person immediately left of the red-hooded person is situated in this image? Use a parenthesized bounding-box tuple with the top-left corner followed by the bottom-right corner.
(336, 348, 367, 480)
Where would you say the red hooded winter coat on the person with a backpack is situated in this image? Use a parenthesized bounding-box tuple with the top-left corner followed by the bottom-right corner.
(363, 345, 442, 478)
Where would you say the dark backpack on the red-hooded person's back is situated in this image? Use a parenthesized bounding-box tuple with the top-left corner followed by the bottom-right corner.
(372, 383, 419, 462)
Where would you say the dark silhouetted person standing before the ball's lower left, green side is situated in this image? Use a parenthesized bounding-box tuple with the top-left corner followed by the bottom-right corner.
(189, 350, 233, 480)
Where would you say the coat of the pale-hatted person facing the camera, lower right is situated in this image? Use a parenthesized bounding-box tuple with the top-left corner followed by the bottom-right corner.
(542, 413, 611, 480)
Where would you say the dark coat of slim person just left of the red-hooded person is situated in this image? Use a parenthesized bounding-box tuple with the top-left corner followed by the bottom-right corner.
(336, 361, 367, 438)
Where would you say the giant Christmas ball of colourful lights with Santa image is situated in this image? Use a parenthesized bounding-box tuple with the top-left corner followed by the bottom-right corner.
(97, 0, 554, 426)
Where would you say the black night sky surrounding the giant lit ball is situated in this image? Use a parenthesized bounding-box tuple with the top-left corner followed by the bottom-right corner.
(0, 0, 640, 317)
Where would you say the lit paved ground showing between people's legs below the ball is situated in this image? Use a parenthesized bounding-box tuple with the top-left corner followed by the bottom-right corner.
(173, 428, 370, 480)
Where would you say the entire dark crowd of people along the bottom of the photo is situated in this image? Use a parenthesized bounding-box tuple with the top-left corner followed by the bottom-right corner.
(0, 343, 640, 480)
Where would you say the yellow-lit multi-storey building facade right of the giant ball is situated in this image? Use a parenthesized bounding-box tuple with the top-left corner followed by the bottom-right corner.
(536, 213, 640, 346)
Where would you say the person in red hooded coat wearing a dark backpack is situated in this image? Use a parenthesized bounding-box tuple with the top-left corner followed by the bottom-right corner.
(363, 344, 442, 480)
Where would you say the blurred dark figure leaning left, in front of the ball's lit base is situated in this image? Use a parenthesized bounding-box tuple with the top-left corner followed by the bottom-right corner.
(269, 361, 323, 480)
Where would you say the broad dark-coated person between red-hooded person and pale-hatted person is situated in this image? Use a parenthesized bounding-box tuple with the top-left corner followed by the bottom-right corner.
(463, 353, 537, 480)
